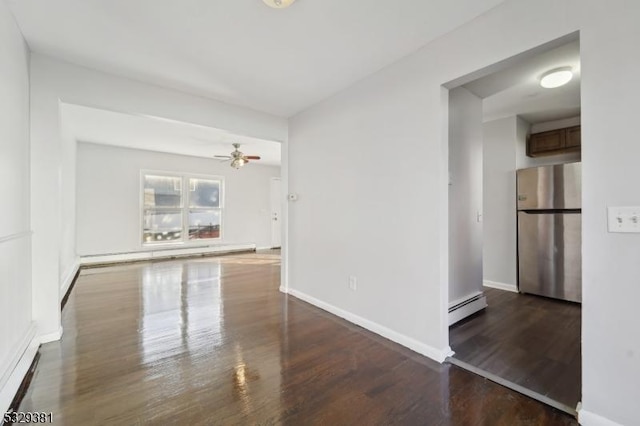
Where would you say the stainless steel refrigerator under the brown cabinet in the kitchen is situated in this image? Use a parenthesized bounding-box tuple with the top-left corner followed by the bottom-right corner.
(517, 163, 582, 302)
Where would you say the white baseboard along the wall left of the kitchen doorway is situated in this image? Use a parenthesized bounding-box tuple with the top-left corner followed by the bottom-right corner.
(288, 287, 453, 363)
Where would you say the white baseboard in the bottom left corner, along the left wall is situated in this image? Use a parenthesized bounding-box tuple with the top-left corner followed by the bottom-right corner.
(0, 323, 40, 416)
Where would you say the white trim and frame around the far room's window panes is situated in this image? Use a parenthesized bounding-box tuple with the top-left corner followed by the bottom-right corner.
(138, 169, 226, 247)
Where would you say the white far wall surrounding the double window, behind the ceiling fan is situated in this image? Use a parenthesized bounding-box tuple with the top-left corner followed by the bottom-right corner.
(76, 143, 280, 256)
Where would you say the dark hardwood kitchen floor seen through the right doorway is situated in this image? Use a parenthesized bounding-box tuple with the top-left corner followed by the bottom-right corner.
(449, 288, 581, 408)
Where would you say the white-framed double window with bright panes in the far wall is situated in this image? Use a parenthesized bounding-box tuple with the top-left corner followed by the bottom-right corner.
(142, 172, 223, 244)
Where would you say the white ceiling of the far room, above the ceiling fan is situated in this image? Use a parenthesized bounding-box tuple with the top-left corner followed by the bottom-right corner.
(62, 104, 281, 166)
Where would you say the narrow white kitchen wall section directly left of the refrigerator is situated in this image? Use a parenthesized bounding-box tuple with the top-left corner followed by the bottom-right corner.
(482, 117, 518, 288)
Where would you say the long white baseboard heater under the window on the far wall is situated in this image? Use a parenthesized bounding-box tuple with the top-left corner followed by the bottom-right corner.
(80, 244, 256, 265)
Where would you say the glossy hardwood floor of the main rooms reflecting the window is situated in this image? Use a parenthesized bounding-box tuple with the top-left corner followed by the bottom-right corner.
(20, 254, 577, 426)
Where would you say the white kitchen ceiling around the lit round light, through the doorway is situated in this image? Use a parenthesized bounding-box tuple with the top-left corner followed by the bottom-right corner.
(464, 40, 580, 124)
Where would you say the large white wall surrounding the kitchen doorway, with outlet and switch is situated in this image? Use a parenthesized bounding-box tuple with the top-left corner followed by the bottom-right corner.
(288, 0, 640, 425)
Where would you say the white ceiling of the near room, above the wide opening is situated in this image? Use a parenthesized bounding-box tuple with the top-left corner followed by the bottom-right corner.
(5, 0, 504, 117)
